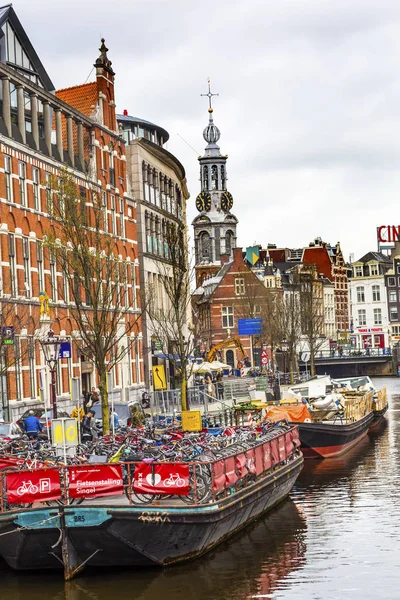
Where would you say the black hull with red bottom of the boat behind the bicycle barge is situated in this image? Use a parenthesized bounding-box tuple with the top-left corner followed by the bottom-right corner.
(296, 411, 374, 458)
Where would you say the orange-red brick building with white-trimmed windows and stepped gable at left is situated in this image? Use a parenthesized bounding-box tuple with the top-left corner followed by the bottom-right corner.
(0, 6, 143, 416)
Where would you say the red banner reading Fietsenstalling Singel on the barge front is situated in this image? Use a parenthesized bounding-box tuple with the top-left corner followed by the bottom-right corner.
(68, 465, 124, 498)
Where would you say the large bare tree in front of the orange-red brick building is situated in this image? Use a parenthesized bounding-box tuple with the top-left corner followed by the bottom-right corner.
(44, 170, 140, 434)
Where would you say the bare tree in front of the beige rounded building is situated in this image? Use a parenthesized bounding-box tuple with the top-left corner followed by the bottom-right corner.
(146, 223, 195, 410)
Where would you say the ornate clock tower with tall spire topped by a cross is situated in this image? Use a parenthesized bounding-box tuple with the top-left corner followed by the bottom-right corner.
(192, 80, 238, 285)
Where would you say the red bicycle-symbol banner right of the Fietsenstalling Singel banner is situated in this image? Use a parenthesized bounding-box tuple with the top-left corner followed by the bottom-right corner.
(133, 463, 189, 496)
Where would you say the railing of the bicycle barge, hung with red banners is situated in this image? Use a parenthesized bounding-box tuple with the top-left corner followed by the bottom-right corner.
(0, 425, 300, 513)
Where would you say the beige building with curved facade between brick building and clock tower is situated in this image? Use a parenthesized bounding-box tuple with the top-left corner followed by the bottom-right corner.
(117, 110, 191, 388)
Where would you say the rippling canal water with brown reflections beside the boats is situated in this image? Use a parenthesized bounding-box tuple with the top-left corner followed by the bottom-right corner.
(0, 378, 400, 600)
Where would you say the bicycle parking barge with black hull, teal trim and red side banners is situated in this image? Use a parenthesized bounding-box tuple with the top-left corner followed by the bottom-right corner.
(0, 426, 303, 580)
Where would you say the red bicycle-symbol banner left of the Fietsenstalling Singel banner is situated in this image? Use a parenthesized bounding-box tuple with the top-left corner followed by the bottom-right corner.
(6, 469, 61, 504)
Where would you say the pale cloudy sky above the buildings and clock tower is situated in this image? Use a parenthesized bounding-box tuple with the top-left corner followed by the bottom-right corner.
(13, 0, 400, 258)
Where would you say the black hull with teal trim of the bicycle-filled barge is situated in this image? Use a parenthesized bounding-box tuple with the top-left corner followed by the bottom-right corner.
(0, 455, 303, 579)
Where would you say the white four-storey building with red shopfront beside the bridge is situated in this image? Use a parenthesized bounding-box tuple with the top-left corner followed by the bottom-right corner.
(349, 252, 390, 350)
